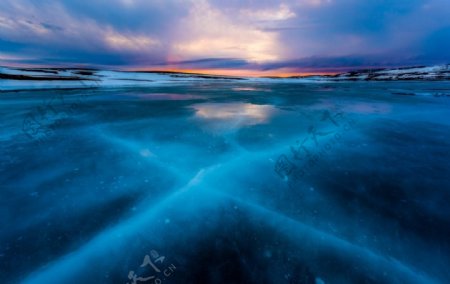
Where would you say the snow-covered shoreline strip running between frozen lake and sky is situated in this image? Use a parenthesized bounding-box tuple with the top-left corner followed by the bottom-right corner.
(0, 64, 450, 91)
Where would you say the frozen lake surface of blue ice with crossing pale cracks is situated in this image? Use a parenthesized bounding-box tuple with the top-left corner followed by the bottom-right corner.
(0, 80, 450, 283)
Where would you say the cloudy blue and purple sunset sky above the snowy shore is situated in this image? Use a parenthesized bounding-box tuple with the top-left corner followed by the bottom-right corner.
(0, 0, 450, 76)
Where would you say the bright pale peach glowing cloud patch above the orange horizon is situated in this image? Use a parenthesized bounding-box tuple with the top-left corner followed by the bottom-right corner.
(171, 0, 280, 62)
